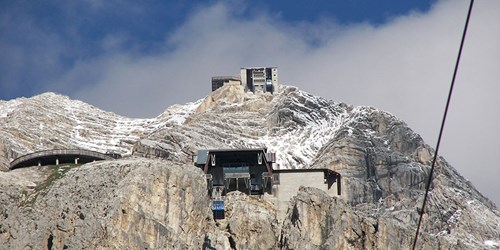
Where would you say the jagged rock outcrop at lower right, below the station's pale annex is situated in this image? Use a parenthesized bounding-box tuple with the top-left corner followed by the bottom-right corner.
(280, 187, 498, 249)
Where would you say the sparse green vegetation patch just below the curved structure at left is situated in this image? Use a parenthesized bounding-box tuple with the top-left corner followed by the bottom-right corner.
(19, 164, 79, 207)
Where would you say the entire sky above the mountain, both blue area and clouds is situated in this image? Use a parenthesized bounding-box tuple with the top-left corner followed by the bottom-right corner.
(0, 0, 500, 205)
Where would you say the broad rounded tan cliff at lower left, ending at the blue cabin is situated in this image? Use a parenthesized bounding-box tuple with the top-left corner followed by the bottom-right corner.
(1, 159, 214, 249)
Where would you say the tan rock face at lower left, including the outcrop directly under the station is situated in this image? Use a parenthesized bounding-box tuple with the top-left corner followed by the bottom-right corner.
(0, 158, 278, 249)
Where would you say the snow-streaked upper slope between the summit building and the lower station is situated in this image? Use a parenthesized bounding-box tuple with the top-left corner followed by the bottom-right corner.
(139, 86, 412, 169)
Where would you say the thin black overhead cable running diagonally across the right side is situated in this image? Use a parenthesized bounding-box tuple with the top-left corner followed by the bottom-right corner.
(412, 0, 474, 250)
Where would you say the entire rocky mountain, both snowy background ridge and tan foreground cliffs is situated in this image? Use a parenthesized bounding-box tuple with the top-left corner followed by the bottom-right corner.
(0, 85, 500, 249)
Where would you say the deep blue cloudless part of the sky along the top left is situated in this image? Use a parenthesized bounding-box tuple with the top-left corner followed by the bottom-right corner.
(0, 0, 434, 101)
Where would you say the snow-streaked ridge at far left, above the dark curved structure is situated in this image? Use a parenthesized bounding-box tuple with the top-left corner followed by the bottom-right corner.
(0, 93, 197, 169)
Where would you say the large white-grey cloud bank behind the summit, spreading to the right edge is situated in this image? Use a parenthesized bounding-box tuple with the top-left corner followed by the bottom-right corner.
(47, 0, 500, 204)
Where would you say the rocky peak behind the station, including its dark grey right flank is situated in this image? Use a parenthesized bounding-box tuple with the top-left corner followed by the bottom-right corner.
(135, 86, 500, 248)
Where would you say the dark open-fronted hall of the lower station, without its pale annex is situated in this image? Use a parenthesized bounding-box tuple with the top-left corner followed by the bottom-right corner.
(195, 148, 276, 195)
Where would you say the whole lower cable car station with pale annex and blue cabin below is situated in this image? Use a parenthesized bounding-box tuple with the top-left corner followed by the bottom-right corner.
(195, 148, 341, 219)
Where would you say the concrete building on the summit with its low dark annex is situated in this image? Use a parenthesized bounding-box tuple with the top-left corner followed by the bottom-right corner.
(212, 67, 279, 94)
